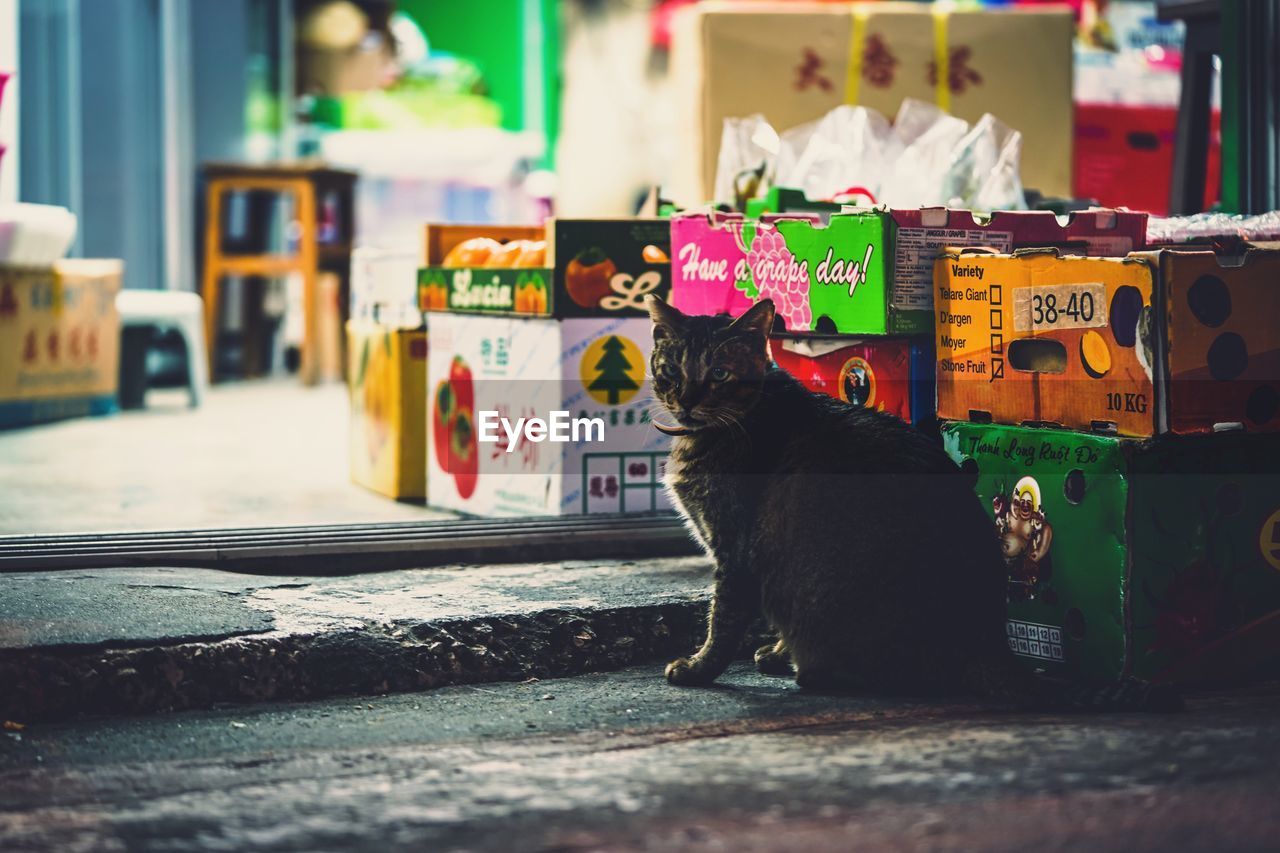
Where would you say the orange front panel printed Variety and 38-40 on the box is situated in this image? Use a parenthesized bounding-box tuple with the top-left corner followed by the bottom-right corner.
(933, 244, 1158, 435)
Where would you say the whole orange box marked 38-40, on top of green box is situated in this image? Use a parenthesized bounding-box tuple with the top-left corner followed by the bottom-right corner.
(934, 247, 1280, 437)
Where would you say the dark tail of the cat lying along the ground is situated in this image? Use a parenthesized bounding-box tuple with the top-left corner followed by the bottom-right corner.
(965, 654, 1183, 713)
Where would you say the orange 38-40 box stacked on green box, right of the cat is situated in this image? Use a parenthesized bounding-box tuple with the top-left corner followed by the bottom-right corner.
(934, 247, 1280, 680)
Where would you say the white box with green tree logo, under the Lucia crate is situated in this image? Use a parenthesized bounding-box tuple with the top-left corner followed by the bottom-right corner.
(426, 314, 669, 516)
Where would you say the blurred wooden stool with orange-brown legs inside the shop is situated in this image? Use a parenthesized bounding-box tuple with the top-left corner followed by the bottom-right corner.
(202, 163, 357, 386)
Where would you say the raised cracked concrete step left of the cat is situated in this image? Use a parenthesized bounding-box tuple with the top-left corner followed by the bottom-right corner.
(0, 558, 709, 722)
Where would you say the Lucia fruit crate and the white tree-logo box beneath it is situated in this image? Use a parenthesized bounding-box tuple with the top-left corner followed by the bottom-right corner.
(419, 219, 671, 516)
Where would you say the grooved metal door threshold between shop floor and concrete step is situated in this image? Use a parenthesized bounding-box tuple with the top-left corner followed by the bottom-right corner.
(0, 514, 698, 575)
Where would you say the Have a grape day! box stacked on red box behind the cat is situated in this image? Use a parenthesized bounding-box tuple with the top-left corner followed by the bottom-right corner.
(671, 204, 1146, 425)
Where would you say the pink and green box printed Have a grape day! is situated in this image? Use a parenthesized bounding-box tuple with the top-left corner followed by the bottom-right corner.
(671, 206, 1147, 334)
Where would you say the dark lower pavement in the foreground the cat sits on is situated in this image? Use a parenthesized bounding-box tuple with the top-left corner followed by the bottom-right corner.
(0, 663, 1280, 853)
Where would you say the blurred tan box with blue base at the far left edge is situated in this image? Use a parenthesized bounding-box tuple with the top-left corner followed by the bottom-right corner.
(0, 260, 124, 428)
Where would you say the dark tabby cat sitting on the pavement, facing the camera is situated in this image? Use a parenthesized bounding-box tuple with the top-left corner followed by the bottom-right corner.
(648, 296, 1176, 710)
